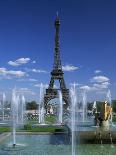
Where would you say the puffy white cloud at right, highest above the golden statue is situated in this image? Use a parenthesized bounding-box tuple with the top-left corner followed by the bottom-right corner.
(90, 76, 110, 83)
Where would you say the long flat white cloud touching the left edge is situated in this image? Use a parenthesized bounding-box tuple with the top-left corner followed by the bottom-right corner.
(0, 68, 26, 77)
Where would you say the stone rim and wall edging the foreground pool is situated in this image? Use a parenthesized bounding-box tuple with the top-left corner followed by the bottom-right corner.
(0, 131, 116, 144)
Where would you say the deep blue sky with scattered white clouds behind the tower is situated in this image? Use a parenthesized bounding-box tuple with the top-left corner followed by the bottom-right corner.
(0, 0, 116, 99)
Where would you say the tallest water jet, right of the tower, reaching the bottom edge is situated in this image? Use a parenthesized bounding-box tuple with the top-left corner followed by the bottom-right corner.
(70, 83, 77, 155)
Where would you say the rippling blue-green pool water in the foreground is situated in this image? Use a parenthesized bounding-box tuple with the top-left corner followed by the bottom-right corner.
(0, 134, 116, 155)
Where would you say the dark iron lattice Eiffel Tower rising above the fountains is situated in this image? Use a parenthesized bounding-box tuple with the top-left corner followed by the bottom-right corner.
(44, 15, 70, 113)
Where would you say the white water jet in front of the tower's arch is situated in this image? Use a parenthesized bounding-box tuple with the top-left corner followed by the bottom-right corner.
(58, 90, 63, 124)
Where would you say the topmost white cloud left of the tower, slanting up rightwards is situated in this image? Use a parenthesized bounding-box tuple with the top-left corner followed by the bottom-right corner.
(8, 58, 30, 67)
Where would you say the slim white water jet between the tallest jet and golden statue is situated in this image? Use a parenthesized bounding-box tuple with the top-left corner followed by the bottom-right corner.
(82, 90, 87, 122)
